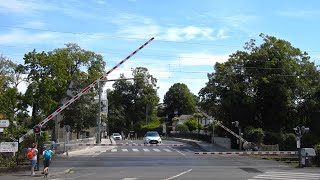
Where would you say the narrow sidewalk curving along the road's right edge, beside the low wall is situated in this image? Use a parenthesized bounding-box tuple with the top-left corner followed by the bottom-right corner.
(172, 138, 230, 152)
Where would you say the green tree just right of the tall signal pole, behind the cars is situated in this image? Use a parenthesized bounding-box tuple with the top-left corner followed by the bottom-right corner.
(108, 67, 159, 131)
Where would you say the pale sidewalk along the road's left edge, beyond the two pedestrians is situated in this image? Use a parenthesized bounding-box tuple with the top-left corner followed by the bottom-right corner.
(58, 139, 115, 157)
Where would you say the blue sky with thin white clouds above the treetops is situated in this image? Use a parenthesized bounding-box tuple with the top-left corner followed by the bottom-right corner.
(0, 0, 320, 102)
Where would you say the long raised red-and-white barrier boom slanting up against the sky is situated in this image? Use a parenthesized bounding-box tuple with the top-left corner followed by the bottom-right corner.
(19, 37, 154, 142)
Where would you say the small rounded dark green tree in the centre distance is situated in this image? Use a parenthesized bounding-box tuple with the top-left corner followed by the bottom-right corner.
(163, 83, 196, 123)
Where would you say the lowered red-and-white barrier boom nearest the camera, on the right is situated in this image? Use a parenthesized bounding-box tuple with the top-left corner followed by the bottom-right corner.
(194, 151, 297, 155)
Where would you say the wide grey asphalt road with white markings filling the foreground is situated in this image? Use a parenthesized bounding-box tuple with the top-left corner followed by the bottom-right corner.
(0, 140, 320, 180)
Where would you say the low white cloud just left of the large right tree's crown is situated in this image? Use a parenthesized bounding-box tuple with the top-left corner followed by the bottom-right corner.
(173, 52, 229, 66)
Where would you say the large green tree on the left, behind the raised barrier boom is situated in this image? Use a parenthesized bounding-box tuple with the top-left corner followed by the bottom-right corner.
(24, 44, 105, 132)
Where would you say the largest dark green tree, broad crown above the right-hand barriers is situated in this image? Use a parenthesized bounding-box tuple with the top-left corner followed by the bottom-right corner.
(199, 34, 319, 132)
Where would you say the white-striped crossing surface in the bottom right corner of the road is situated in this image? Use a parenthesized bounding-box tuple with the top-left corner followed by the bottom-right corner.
(248, 171, 320, 180)
